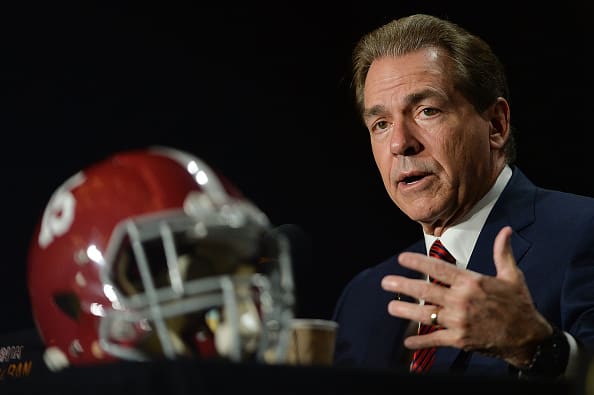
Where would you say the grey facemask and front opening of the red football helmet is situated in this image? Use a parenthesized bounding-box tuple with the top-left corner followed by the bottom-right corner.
(99, 194, 293, 362)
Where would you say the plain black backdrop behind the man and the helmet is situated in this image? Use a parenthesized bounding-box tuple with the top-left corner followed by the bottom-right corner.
(0, 0, 594, 331)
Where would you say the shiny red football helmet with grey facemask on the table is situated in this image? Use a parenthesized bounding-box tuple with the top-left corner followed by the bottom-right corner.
(28, 147, 294, 370)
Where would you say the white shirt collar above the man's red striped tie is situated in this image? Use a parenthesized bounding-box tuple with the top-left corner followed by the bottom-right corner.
(424, 165, 512, 269)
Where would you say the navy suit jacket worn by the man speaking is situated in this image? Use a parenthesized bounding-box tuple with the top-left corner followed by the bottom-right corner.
(333, 168, 594, 375)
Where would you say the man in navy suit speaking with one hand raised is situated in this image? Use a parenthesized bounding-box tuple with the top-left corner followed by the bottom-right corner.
(334, 15, 594, 378)
